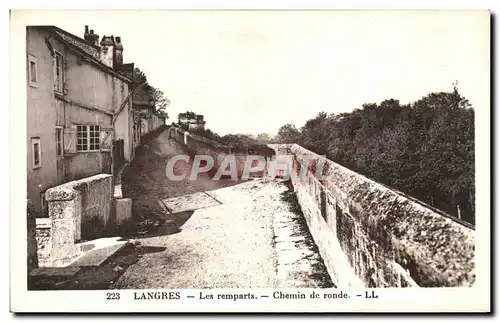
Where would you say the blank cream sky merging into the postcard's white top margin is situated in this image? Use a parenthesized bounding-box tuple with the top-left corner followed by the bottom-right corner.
(14, 10, 490, 135)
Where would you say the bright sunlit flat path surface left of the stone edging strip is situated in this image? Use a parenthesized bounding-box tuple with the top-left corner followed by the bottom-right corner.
(114, 182, 277, 288)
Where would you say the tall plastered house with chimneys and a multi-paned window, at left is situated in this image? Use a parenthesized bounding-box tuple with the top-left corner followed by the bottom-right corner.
(26, 26, 139, 217)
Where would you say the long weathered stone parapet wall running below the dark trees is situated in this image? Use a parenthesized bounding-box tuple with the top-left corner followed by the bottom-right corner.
(270, 144, 475, 287)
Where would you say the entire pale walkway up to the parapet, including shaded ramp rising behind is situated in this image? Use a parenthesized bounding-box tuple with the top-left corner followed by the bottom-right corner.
(112, 132, 332, 288)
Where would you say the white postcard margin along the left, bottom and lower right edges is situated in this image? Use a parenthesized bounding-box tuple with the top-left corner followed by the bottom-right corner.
(10, 8, 491, 312)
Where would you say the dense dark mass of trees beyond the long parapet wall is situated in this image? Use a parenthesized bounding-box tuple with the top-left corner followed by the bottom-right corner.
(277, 87, 475, 223)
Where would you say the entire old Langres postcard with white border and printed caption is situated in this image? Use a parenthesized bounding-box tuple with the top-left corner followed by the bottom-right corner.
(10, 10, 491, 313)
